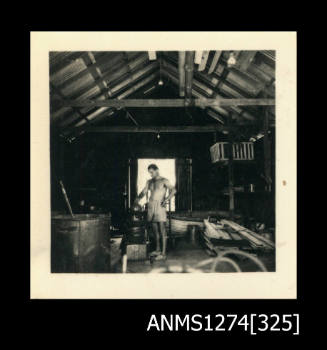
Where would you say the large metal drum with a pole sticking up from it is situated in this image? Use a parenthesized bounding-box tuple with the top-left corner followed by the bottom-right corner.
(51, 214, 110, 273)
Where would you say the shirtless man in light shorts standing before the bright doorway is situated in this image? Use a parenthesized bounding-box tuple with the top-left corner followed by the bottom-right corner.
(135, 164, 176, 260)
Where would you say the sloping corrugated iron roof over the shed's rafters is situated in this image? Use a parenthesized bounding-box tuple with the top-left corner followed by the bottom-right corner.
(49, 51, 275, 138)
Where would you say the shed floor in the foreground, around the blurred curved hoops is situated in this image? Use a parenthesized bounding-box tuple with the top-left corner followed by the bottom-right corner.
(115, 239, 275, 273)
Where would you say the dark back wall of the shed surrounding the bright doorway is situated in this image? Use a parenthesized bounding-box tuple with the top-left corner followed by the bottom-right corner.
(51, 133, 274, 227)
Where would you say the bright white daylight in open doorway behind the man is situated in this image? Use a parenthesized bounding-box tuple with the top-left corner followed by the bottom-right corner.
(137, 159, 176, 211)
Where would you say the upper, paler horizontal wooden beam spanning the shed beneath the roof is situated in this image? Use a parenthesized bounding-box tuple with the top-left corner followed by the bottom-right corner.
(62, 98, 275, 107)
